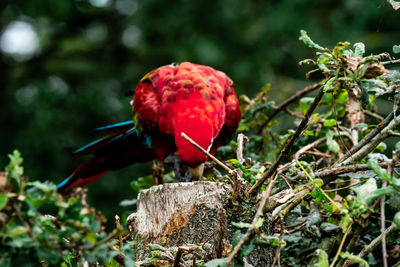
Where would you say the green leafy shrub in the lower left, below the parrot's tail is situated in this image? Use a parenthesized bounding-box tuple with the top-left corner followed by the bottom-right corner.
(0, 150, 133, 267)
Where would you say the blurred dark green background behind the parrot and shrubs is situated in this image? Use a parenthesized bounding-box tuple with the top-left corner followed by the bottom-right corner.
(0, 0, 400, 226)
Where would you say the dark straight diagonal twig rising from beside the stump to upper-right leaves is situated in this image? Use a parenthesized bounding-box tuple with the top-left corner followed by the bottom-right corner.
(246, 86, 324, 195)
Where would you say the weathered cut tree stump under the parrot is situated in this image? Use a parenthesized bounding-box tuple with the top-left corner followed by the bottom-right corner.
(128, 181, 273, 266)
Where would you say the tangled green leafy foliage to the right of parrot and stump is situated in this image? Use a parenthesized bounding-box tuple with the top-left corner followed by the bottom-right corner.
(219, 31, 400, 266)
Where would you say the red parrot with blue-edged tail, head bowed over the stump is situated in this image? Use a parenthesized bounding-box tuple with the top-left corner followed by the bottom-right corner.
(58, 62, 241, 193)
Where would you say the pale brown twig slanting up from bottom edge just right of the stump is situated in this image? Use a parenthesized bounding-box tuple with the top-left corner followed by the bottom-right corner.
(227, 175, 276, 267)
